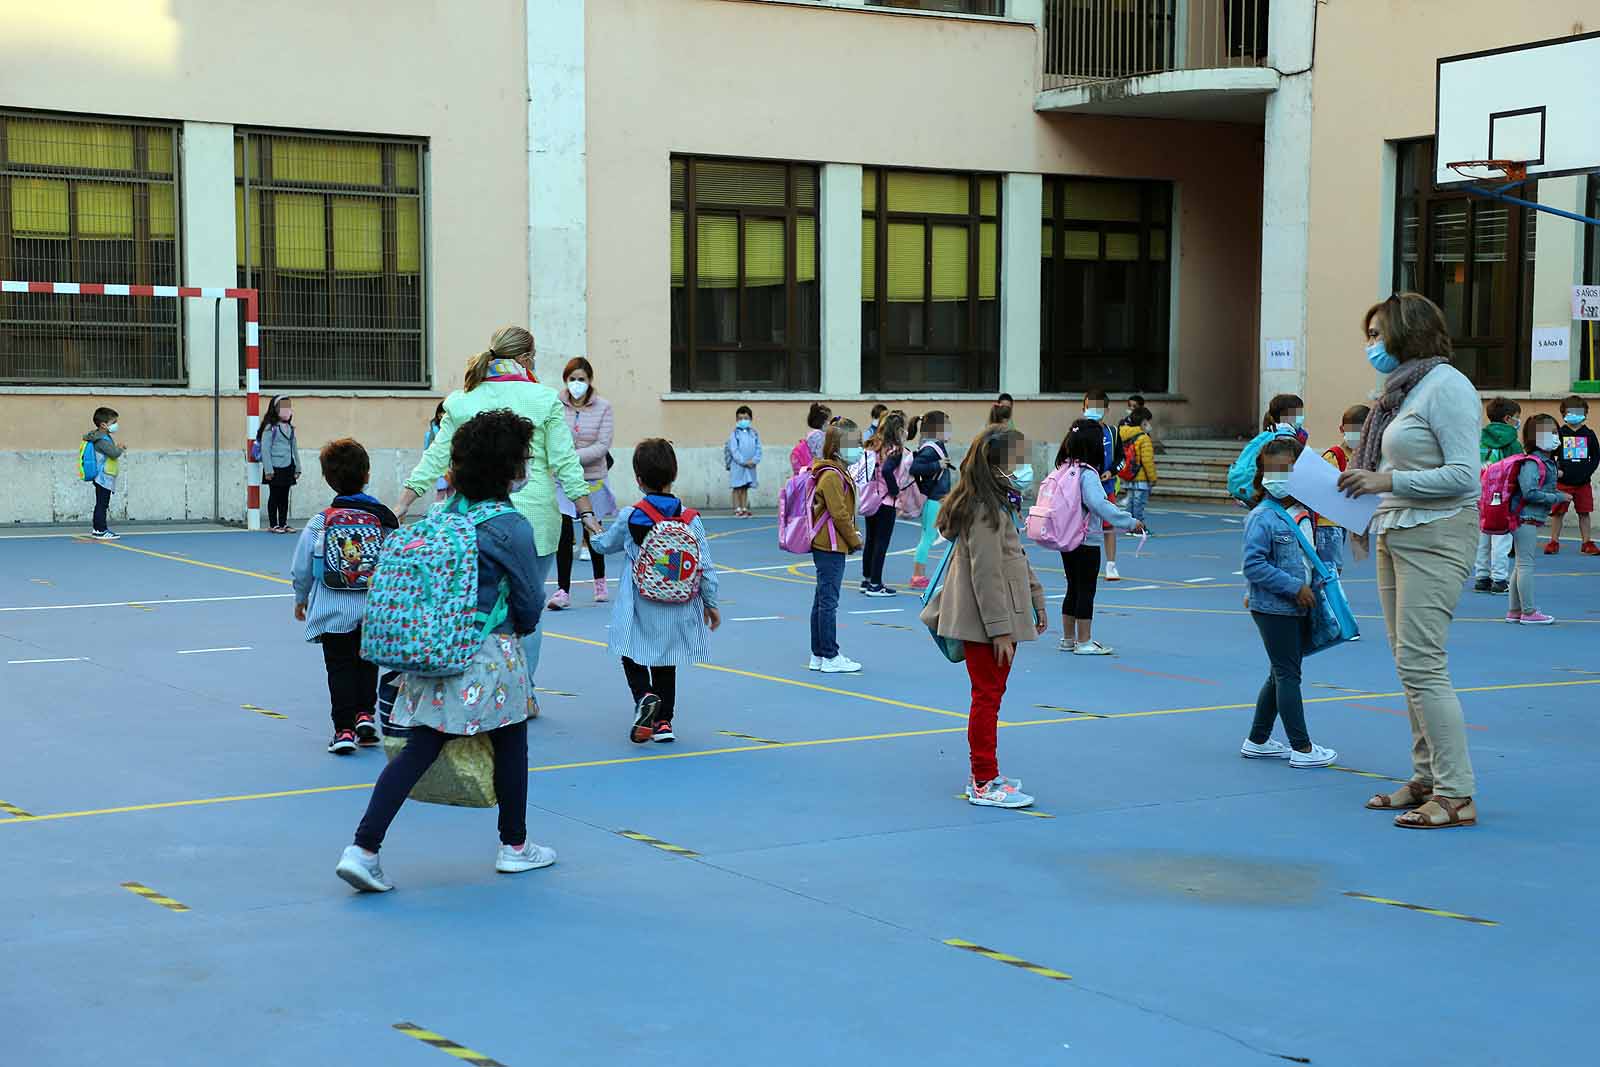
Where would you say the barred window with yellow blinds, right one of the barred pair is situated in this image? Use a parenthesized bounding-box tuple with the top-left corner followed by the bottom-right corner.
(234, 131, 430, 389)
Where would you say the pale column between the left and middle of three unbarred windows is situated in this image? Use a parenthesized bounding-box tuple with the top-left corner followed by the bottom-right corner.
(821, 163, 861, 397)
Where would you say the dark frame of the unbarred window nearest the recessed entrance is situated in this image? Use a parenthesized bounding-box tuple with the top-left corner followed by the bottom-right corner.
(1038, 174, 1176, 394)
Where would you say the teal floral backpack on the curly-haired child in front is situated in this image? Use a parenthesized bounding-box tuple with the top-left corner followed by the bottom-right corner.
(362, 496, 515, 677)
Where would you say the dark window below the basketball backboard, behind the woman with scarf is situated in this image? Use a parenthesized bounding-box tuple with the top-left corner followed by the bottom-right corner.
(1394, 139, 1538, 389)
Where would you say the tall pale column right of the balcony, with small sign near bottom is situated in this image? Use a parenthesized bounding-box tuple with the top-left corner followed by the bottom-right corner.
(1258, 0, 1317, 403)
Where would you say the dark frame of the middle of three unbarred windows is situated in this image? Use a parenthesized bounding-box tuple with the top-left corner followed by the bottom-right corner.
(861, 166, 1005, 395)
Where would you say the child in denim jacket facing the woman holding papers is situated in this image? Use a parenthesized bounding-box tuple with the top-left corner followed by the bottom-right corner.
(1238, 435, 1339, 768)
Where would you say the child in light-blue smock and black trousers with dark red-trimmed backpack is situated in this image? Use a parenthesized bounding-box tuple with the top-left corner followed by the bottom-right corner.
(290, 437, 400, 755)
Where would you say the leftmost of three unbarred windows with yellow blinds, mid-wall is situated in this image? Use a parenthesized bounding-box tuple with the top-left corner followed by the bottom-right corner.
(672, 157, 822, 392)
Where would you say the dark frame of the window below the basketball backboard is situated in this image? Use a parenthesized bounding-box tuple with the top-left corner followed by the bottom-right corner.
(1392, 138, 1538, 392)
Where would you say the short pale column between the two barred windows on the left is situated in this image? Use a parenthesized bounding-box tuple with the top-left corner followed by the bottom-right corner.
(179, 122, 243, 388)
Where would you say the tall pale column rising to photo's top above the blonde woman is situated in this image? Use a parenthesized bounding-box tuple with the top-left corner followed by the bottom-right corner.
(526, 0, 592, 381)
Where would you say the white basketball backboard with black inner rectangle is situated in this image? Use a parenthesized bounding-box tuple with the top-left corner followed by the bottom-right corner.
(1434, 32, 1600, 186)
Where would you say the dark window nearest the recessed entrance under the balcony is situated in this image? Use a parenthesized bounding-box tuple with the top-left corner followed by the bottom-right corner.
(1038, 178, 1173, 392)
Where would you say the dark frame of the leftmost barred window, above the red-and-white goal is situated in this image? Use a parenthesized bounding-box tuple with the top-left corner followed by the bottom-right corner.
(0, 107, 189, 387)
